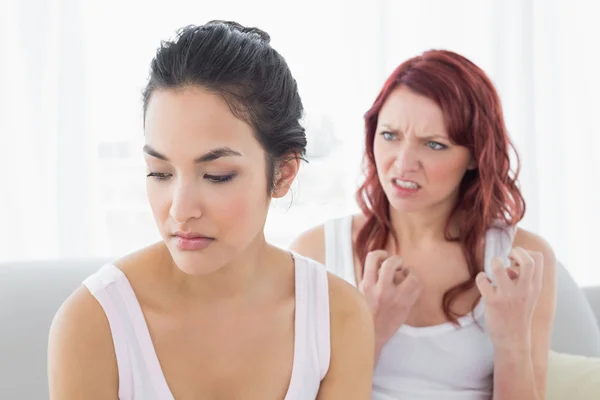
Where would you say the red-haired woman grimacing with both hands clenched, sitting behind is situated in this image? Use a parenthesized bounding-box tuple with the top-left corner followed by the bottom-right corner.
(292, 51, 556, 400)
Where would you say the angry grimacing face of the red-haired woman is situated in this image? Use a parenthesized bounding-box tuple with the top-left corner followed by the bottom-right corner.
(373, 86, 476, 213)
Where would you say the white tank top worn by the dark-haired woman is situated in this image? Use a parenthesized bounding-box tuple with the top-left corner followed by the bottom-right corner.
(83, 253, 330, 400)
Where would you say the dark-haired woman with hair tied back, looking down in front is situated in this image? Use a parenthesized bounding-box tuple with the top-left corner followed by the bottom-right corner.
(49, 21, 375, 400)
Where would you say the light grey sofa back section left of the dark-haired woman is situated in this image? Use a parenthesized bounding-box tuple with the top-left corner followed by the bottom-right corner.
(0, 260, 106, 399)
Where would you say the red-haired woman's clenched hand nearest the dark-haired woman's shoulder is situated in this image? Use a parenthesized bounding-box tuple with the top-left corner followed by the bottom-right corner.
(358, 250, 423, 359)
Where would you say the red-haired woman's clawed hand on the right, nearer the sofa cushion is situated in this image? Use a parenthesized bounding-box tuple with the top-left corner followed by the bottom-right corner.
(476, 247, 544, 349)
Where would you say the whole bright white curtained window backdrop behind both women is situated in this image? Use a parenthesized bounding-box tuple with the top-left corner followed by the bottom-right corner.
(0, 0, 600, 284)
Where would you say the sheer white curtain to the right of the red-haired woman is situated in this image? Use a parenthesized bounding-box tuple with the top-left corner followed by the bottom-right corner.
(494, 0, 600, 285)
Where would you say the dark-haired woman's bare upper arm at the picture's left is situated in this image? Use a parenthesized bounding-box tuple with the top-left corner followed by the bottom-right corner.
(48, 287, 119, 400)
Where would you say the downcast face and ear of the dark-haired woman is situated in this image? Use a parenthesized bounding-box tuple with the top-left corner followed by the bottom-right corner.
(144, 86, 298, 275)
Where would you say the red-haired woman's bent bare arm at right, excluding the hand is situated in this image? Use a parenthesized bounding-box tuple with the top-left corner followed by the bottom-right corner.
(478, 230, 556, 400)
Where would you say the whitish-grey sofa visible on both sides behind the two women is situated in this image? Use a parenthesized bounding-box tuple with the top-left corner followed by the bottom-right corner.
(0, 260, 600, 400)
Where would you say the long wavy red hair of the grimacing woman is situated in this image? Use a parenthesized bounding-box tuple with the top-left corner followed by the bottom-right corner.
(354, 50, 525, 324)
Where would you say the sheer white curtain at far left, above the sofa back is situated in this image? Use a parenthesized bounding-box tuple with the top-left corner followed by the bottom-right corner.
(0, 0, 90, 259)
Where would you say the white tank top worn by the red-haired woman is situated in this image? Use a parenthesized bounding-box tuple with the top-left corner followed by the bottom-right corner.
(325, 216, 514, 400)
